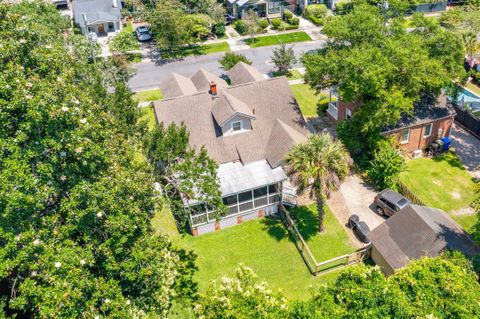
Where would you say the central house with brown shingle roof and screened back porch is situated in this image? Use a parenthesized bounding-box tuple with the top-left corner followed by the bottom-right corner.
(154, 62, 308, 235)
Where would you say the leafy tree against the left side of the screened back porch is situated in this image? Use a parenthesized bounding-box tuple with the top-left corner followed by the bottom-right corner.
(144, 123, 225, 230)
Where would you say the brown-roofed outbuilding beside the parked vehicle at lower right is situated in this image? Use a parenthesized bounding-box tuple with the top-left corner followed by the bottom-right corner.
(368, 205, 480, 275)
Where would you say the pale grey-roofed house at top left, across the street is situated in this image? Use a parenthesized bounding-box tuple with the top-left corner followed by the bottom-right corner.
(72, 0, 122, 36)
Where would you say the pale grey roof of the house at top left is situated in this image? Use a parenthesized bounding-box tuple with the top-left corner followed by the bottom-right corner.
(72, 0, 122, 24)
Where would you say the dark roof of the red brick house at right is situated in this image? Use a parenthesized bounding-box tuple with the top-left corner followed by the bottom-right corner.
(383, 94, 455, 132)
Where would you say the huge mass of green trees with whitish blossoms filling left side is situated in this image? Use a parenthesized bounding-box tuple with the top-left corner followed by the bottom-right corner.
(0, 1, 193, 318)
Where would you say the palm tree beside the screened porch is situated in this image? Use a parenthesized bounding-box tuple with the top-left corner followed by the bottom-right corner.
(285, 133, 349, 232)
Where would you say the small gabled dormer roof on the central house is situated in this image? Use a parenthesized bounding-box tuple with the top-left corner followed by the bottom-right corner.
(212, 92, 255, 126)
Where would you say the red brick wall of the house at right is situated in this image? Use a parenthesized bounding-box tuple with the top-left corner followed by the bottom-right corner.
(385, 118, 453, 152)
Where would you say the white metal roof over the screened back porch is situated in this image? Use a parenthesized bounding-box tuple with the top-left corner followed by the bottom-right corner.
(217, 160, 287, 196)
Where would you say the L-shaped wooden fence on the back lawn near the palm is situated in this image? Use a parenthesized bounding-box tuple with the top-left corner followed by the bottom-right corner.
(279, 205, 370, 276)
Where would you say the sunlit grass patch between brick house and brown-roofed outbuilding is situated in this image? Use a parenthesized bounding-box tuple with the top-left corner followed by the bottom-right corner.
(400, 152, 474, 212)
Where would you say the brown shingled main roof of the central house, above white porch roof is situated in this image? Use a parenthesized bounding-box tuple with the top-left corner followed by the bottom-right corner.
(154, 69, 308, 167)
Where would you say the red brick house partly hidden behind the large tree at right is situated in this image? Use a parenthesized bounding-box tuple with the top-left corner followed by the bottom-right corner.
(327, 91, 455, 152)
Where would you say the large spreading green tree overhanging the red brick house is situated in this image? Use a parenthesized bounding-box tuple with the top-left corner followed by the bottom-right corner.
(302, 4, 466, 153)
